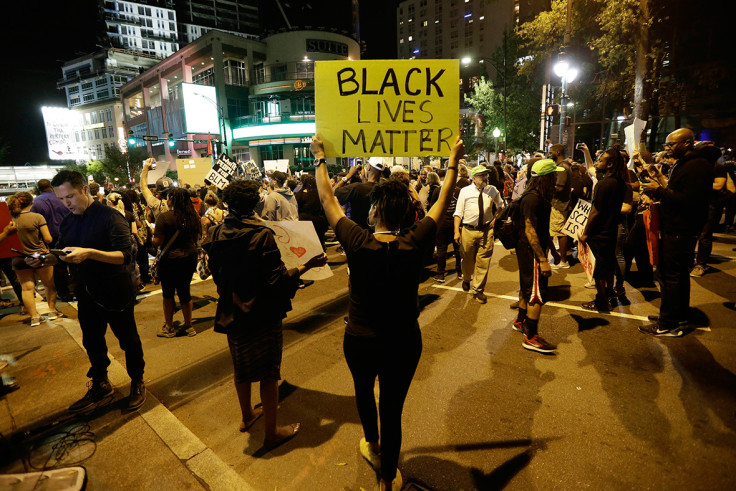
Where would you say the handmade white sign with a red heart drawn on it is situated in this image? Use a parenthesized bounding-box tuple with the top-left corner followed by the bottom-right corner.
(264, 220, 332, 280)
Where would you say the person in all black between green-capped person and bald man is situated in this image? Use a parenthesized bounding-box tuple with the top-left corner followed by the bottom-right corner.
(580, 145, 630, 312)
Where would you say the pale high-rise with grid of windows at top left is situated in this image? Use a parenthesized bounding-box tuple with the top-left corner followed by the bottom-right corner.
(100, 0, 179, 58)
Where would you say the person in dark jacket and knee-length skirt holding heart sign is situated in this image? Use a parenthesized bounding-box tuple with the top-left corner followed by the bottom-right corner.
(203, 180, 327, 449)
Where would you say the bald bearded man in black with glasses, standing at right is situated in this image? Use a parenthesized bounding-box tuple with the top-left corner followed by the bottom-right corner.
(639, 128, 713, 337)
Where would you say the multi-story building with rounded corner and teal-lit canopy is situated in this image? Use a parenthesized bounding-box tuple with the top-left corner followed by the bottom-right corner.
(121, 29, 360, 169)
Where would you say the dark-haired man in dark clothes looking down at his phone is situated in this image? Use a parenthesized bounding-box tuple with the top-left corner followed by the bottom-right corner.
(26, 170, 146, 413)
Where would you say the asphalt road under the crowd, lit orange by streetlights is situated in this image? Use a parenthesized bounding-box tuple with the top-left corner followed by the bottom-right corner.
(1, 236, 736, 491)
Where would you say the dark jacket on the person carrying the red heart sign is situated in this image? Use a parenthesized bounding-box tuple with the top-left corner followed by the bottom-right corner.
(202, 216, 299, 332)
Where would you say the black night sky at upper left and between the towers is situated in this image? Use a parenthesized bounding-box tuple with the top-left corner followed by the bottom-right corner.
(0, 0, 399, 165)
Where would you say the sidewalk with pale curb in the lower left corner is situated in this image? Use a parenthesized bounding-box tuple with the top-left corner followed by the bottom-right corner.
(0, 294, 250, 489)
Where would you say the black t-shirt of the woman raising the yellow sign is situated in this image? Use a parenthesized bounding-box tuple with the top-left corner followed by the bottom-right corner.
(335, 217, 437, 337)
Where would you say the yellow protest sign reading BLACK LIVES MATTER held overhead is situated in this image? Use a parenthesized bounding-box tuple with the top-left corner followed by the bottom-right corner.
(314, 60, 460, 157)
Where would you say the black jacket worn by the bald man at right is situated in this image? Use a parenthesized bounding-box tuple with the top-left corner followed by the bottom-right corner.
(654, 151, 713, 236)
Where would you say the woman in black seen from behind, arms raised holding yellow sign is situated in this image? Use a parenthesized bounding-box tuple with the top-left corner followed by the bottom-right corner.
(311, 135, 465, 490)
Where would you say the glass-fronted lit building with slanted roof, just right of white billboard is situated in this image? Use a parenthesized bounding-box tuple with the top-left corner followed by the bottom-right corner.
(57, 48, 158, 161)
